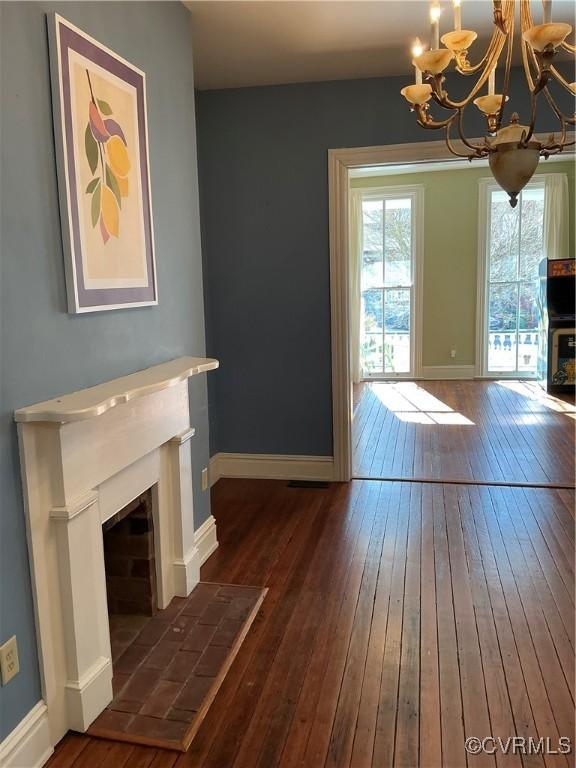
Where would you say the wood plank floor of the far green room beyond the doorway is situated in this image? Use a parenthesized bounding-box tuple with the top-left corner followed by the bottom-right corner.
(352, 381, 576, 487)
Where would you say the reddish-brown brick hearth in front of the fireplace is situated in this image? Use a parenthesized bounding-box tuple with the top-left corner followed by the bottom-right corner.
(88, 582, 267, 750)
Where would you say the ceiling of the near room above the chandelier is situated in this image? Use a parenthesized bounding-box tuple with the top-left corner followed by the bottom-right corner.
(185, 0, 574, 89)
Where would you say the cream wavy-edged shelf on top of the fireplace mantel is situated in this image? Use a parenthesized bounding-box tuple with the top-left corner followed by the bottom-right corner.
(14, 357, 219, 423)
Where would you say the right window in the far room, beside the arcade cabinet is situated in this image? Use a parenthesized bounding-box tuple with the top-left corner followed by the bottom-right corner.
(479, 181, 544, 377)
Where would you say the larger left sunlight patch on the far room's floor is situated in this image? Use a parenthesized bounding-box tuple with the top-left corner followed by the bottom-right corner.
(370, 381, 475, 427)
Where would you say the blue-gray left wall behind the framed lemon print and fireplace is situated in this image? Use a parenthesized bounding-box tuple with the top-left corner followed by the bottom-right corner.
(0, 2, 209, 740)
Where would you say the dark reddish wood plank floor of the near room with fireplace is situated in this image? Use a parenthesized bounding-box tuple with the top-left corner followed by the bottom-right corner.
(50, 480, 575, 768)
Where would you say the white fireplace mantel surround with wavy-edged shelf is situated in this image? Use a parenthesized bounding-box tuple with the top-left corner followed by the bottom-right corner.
(15, 357, 218, 745)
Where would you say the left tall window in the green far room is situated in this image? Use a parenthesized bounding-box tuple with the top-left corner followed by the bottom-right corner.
(360, 187, 421, 378)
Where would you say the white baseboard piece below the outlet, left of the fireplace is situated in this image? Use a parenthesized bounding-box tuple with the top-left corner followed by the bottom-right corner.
(0, 701, 54, 768)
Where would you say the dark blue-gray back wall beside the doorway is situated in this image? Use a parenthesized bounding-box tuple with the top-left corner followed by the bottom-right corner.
(197, 72, 568, 455)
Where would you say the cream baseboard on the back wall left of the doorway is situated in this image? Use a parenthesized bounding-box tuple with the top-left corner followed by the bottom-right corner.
(210, 453, 334, 485)
